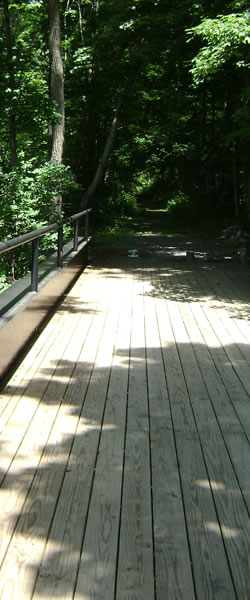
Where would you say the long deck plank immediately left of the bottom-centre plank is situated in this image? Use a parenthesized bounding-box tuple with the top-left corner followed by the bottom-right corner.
(74, 274, 133, 600)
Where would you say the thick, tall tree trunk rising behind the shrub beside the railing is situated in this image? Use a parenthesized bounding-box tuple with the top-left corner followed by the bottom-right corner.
(48, 0, 65, 214)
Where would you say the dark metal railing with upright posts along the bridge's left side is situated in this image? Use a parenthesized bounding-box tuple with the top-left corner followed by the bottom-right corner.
(0, 208, 93, 292)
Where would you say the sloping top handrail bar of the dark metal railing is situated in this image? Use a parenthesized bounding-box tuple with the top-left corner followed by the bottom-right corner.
(0, 208, 92, 254)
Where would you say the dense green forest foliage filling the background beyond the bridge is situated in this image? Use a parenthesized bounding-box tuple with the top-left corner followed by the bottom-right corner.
(0, 0, 250, 288)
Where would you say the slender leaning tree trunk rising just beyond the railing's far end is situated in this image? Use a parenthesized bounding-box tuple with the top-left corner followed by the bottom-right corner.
(79, 65, 140, 210)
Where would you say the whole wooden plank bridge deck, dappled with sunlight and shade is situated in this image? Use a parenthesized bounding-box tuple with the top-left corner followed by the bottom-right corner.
(0, 259, 250, 600)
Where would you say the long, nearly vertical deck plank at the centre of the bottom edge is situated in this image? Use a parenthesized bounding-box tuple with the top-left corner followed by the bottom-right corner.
(116, 266, 154, 600)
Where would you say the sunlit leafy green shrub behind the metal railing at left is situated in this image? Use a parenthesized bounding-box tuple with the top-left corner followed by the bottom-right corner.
(0, 160, 77, 287)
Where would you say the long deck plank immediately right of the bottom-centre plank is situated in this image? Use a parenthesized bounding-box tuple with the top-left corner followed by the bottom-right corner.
(144, 269, 195, 600)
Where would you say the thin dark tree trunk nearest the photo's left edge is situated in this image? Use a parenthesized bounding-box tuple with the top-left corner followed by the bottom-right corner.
(3, 0, 17, 167)
